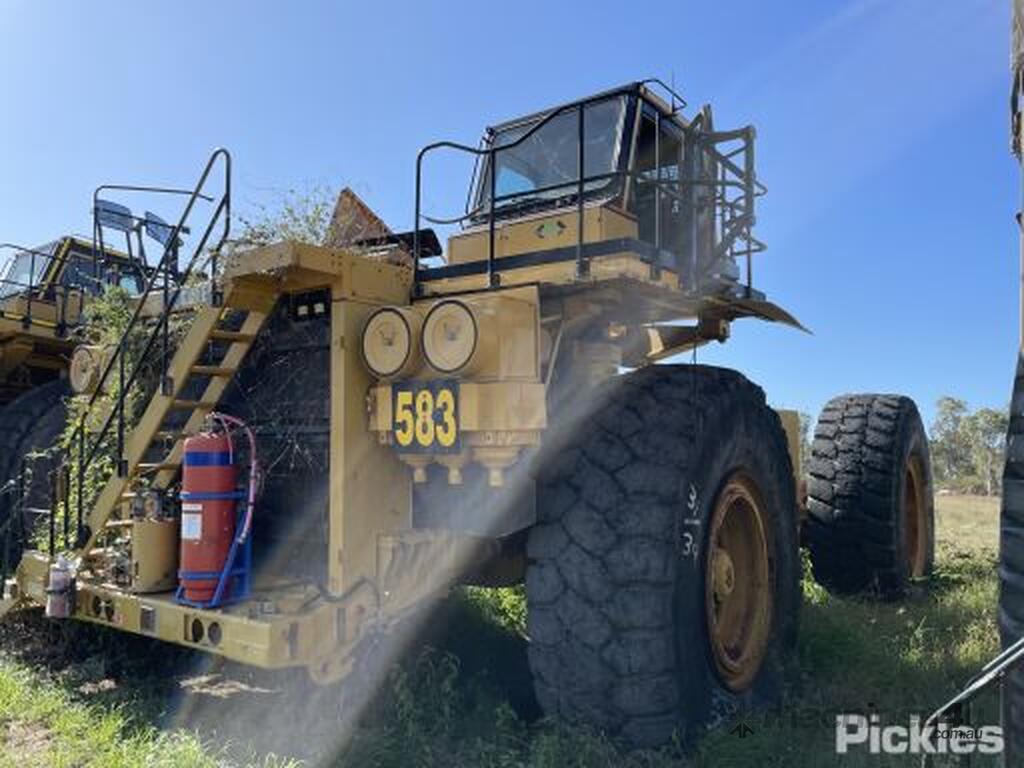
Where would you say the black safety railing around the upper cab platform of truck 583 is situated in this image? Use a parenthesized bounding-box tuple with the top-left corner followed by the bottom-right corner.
(413, 80, 767, 292)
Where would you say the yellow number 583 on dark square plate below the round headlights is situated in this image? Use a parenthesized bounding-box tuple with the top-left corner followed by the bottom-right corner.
(391, 380, 459, 453)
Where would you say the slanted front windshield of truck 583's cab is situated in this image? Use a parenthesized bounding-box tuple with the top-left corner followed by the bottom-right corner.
(475, 96, 626, 217)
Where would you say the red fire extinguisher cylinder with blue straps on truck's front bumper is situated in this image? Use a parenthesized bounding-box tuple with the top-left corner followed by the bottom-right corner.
(179, 432, 240, 603)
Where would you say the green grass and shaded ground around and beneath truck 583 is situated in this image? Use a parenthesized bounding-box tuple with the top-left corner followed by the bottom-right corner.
(0, 497, 998, 768)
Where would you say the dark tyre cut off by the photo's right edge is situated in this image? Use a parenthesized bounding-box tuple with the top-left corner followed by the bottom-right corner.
(999, 358, 1024, 766)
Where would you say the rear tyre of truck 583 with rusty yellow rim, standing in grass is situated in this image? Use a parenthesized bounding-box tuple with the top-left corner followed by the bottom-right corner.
(806, 394, 935, 598)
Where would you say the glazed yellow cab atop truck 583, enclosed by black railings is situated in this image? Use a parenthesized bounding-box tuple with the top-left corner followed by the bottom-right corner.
(414, 81, 764, 298)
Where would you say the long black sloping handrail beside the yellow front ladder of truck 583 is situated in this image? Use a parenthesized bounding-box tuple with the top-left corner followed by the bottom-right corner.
(76, 147, 231, 548)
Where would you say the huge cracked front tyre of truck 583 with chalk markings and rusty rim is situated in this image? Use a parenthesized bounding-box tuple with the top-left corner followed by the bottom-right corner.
(526, 366, 800, 746)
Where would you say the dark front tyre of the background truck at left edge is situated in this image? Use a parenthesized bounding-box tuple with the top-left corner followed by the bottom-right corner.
(0, 380, 69, 556)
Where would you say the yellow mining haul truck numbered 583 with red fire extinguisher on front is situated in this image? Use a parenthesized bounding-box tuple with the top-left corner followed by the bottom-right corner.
(4, 80, 934, 743)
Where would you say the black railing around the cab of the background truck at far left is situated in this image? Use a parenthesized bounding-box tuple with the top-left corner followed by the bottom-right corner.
(0, 243, 85, 336)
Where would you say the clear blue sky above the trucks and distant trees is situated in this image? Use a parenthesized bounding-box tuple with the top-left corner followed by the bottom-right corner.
(0, 0, 1018, 428)
